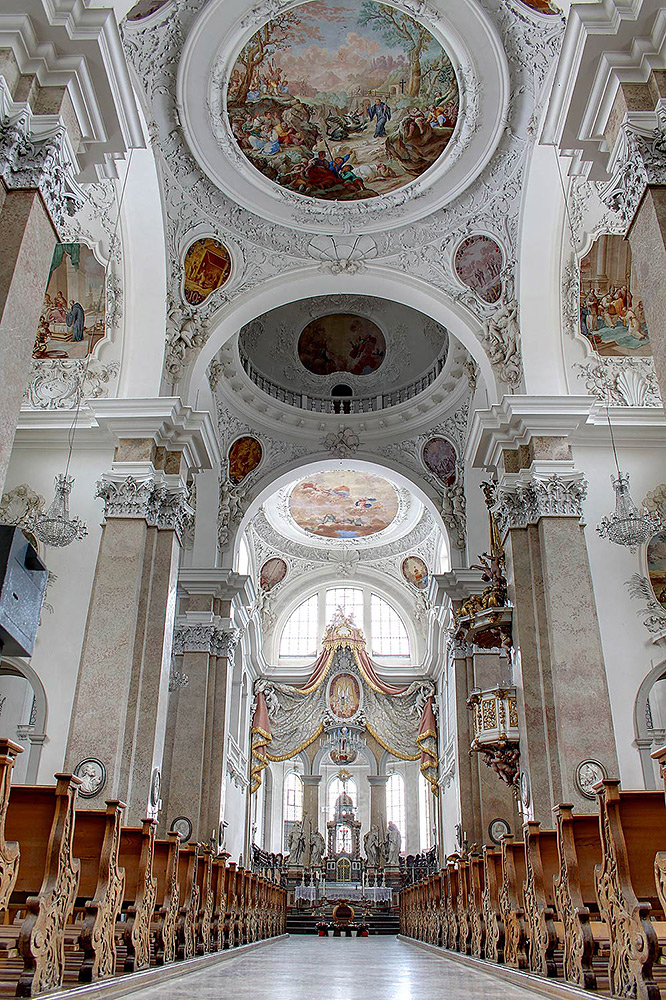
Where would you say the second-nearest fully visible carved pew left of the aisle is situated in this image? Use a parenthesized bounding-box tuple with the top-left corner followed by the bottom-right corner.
(70, 799, 125, 983)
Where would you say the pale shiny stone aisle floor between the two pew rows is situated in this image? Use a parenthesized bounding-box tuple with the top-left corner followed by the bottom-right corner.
(123, 936, 542, 1000)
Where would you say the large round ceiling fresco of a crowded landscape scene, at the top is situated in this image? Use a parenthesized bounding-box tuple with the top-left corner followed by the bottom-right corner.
(227, 0, 460, 201)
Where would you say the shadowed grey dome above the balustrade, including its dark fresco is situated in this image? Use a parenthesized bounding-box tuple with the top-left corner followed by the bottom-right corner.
(238, 295, 449, 396)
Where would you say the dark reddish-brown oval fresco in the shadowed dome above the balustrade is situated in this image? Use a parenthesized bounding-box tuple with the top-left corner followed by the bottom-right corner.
(298, 313, 386, 375)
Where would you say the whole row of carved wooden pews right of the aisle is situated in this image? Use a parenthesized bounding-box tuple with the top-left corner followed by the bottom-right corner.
(400, 747, 666, 1000)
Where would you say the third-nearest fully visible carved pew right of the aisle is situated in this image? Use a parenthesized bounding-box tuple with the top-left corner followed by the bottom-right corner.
(523, 821, 562, 976)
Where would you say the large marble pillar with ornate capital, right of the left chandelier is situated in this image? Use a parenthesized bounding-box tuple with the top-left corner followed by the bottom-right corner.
(65, 438, 191, 824)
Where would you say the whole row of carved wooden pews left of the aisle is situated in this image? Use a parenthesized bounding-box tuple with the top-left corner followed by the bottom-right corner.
(0, 739, 286, 996)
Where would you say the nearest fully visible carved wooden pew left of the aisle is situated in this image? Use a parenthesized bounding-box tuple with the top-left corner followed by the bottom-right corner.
(5, 774, 81, 996)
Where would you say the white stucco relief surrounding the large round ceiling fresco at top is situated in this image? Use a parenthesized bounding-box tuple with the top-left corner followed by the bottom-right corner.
(119, 0, 562, 383)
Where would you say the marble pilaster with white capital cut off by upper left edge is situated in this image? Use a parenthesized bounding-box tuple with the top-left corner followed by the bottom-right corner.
(0, 68, 81, 494)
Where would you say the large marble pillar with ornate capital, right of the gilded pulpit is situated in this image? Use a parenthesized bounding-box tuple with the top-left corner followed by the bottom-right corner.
(493, 438, 618, 825)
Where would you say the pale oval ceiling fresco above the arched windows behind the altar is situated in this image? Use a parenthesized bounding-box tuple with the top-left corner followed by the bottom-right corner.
(289, 470, 398, 538)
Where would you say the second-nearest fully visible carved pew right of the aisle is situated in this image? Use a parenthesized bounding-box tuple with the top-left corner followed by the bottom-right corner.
(553, 803, 609, 990)
